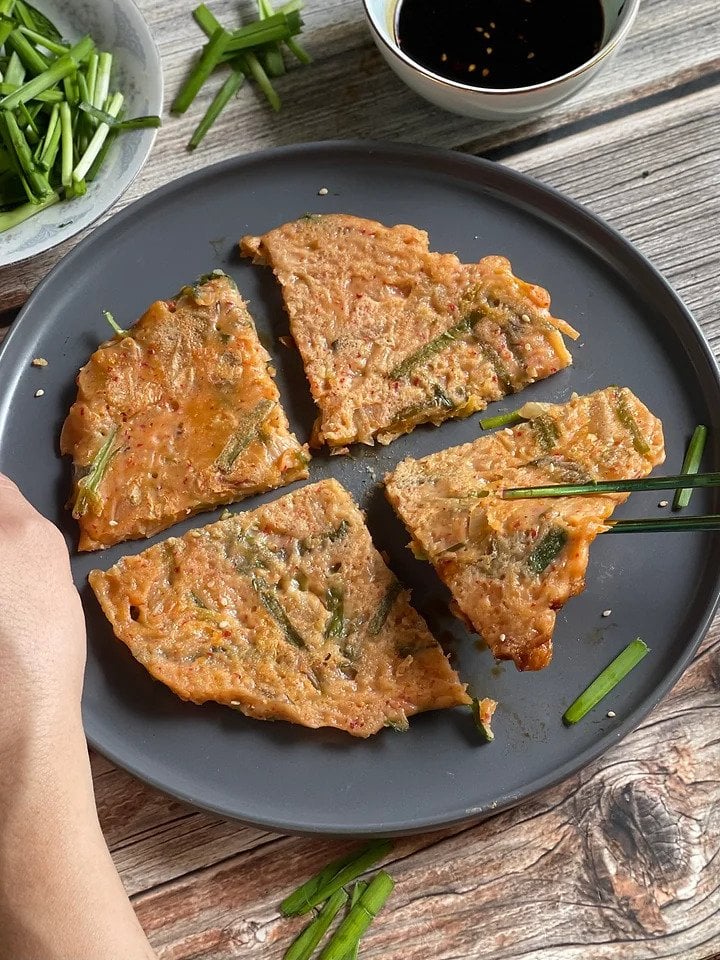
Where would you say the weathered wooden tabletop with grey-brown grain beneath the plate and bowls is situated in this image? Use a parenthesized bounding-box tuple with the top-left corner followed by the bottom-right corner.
(0, 0, 720, 960)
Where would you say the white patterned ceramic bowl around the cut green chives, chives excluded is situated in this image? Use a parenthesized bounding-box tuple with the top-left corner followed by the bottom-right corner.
(0, 0, 163, 266)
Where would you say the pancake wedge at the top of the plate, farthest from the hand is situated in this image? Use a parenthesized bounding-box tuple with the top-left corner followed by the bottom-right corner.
(241, 214, 577, 447)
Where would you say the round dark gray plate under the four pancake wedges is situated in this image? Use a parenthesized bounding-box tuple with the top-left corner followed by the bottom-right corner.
(0, 143, 720, 834)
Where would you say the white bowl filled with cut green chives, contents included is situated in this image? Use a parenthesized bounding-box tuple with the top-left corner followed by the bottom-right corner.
(0, 0, 163, 266)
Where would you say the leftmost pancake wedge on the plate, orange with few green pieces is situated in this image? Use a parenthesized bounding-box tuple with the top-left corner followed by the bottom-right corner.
(60, 272, 309, 550)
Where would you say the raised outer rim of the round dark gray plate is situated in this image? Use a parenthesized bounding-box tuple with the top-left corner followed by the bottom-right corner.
(0, 139, 720, 837)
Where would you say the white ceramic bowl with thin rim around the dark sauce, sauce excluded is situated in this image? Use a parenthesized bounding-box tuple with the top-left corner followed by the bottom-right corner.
(363, 0, 640, 120)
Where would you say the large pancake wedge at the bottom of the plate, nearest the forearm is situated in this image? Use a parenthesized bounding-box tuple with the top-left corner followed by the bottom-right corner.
(90, 480, 470, 737)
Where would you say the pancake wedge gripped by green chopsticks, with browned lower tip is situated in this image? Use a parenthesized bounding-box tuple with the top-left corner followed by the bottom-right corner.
(386, 387, 665, 670)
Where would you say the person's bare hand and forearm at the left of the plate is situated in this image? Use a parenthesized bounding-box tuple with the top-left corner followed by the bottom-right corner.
(0, 474, 154, 960)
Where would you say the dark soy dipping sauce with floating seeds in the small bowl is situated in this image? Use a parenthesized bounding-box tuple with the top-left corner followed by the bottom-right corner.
(396, 0, 605, 90)
